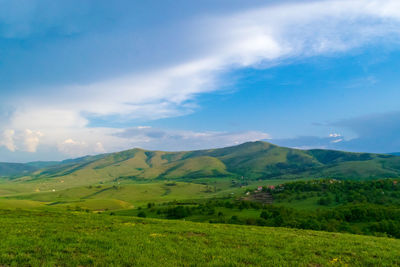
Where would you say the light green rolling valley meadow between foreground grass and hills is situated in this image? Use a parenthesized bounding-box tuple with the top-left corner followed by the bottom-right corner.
(0, 178, 310, 210)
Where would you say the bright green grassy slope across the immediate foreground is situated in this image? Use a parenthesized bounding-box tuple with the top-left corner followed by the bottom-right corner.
(0, 210, 400, 266)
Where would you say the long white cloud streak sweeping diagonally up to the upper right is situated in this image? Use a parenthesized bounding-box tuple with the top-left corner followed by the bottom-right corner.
(15, 0, 400, 123)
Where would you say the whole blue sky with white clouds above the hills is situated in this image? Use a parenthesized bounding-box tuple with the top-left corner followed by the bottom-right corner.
(0, 0, 400, 162)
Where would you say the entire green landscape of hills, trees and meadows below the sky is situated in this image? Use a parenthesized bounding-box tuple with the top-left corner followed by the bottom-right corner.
(0, 142, 400, 266)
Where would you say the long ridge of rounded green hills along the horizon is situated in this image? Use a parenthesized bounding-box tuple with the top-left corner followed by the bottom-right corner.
(6, 141, 400, 181)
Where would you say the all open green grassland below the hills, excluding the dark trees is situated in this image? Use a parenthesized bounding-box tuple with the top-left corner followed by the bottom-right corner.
(0, 174, 400, 266)
